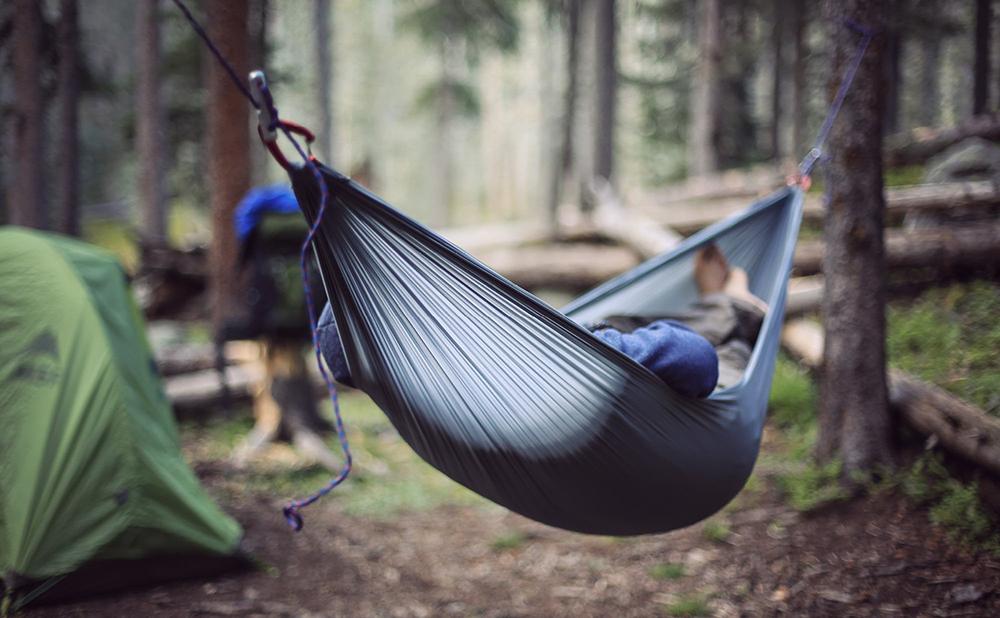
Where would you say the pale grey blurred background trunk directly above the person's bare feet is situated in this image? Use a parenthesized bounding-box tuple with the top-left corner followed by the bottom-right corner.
(688, 0, 722, 176)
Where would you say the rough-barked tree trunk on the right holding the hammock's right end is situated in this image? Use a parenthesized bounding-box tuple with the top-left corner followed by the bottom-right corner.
(816, 0, 891, 478)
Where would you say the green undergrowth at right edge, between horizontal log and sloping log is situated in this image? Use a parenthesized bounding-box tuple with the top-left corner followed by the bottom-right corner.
(886, 281, 1000, 413)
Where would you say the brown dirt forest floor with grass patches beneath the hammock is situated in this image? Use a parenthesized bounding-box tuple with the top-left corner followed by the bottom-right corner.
(25, 387, 1000, 618)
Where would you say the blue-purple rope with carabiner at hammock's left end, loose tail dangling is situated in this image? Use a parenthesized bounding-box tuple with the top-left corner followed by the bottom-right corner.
(174, 0, 353, 531)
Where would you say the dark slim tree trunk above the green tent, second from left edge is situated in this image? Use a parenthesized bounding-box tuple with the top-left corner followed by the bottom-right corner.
(58, 0, 80, 236)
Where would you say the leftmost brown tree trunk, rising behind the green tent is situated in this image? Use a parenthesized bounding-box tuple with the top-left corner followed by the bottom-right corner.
(9, 0, 48, 228)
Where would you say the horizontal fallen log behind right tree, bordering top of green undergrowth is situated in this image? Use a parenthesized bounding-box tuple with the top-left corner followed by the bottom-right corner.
(795, 223, 1000, 276)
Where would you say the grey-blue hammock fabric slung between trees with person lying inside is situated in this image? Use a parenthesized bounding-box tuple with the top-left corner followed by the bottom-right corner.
(291, 164, 802, 535)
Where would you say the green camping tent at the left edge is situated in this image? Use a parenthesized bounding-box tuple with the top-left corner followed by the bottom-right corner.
(0, 227, 245, 603)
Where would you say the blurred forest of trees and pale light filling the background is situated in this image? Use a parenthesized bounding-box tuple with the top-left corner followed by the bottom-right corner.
(0, 0, 1000, 253)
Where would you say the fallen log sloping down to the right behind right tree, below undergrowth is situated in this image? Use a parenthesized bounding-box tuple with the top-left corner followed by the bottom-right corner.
(781, 320, 1000, 475)
